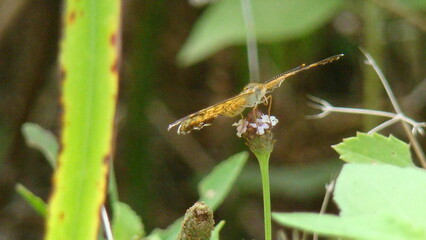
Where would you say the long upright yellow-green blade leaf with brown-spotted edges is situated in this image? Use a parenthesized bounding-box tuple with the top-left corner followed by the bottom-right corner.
(46, 0, 121, 240)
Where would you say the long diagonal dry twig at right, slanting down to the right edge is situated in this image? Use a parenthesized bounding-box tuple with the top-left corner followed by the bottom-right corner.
(361, 48, 426, 168)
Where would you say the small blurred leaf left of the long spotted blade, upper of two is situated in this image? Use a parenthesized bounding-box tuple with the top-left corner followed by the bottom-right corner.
(21, 123, 59, 168)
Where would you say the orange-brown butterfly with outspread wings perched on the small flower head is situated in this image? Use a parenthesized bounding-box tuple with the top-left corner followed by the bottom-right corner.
(168, 54, 343, 135)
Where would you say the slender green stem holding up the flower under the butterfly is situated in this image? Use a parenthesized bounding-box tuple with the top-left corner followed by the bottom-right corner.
(255, 152, 272, 240)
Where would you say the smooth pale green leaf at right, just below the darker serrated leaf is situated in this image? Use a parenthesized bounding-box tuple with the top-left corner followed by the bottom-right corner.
(334, 164, 426, 220)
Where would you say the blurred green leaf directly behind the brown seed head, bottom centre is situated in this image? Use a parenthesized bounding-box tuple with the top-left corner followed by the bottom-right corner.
(198, 152, 248, 210)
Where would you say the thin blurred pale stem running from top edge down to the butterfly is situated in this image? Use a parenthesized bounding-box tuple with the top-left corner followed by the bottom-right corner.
(241, 0, 259, 83)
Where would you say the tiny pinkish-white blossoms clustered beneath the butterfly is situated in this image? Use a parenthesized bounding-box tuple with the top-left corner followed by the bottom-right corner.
(232, 114, 278, 137)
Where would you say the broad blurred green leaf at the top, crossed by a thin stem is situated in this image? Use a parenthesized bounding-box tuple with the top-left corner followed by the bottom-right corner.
(177, 0, 343, 66)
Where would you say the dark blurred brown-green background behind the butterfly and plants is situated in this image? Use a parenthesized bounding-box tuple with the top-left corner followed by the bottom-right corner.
(0, 0, 426, 239)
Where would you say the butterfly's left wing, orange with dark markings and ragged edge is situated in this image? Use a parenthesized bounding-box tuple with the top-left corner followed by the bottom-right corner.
(168, 92, 251, 134)
